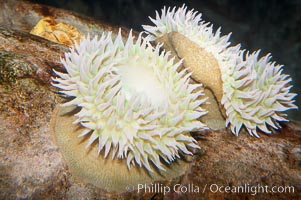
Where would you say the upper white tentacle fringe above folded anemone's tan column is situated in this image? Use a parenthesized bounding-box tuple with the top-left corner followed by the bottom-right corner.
(143, 5, 239, 74)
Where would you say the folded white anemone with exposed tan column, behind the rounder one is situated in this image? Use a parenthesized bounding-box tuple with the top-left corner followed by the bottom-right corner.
(143, 5, 297, 137)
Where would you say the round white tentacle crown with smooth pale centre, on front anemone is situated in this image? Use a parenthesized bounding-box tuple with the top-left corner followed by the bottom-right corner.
(54, 29, 206, 171)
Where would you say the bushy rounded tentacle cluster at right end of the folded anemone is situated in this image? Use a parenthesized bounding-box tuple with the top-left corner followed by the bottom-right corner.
(222, 51, 297, 137)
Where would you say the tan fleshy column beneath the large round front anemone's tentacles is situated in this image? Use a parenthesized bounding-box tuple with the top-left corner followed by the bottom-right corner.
(51, 106, 191, 193)
